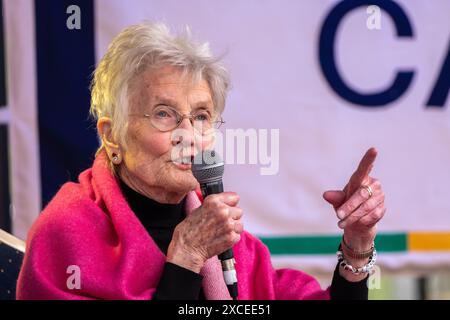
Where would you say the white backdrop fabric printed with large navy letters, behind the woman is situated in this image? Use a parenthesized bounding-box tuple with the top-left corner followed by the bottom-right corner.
(95, 0, 450, 270)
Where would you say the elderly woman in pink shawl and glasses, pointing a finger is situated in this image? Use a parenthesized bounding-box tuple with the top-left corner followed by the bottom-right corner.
(17, 23, 385, 299)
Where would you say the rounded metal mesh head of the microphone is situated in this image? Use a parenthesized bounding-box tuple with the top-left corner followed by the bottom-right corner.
(192, 150, 225, 183)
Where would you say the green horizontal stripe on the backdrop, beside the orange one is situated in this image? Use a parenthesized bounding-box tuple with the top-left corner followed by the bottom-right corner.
(259, 233, 407, 255)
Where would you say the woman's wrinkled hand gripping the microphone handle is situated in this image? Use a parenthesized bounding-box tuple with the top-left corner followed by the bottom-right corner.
(167, 192, 244, 273)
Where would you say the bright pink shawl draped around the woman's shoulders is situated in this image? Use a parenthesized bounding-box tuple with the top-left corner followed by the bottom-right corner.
(17, 153, 329, 300)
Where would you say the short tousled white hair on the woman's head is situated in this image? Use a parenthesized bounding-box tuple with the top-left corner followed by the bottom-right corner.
(90, 22, 230, 151)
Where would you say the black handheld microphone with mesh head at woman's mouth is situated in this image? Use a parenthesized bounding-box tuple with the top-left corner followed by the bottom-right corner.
(192, 150, 238, 300)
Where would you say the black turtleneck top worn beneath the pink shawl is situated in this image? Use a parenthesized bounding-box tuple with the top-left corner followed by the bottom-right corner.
(120, 180, 368, 300)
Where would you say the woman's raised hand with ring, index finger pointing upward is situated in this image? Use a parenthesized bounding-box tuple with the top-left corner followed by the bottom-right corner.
(323, 148, 386, 251)
